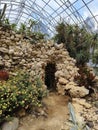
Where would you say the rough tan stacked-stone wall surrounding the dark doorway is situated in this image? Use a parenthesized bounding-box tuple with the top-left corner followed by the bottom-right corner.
(0, 27, 88, 97)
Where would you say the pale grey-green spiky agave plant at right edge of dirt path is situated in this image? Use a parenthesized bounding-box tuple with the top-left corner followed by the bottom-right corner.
(68, 103, 90, 130)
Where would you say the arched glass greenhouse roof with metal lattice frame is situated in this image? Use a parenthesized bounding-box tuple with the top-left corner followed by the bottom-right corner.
(0, 0, 98, 33)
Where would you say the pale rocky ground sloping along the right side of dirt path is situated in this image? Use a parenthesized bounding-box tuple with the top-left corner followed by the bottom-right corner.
(72, 98, 98, 130)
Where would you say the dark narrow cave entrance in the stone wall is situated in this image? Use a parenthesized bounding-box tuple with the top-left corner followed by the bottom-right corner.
(45, 63, 56, 91)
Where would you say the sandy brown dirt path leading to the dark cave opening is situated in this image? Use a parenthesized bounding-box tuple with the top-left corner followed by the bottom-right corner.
(18, 93, 69, 130)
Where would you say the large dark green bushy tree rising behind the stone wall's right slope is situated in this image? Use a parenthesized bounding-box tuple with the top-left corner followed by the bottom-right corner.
(54, 22, 93, 65)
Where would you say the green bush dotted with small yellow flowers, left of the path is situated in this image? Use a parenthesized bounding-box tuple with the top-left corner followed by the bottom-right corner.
(0, 72, 44, 123)
